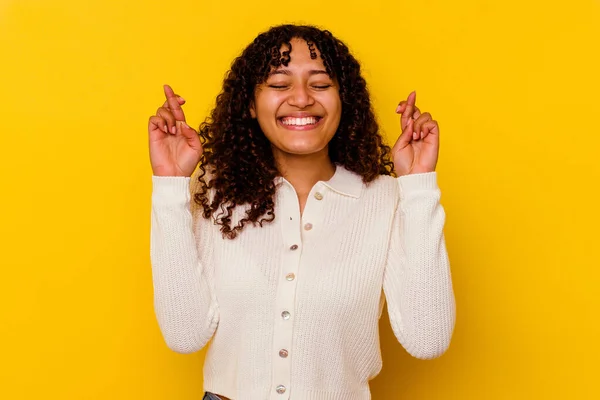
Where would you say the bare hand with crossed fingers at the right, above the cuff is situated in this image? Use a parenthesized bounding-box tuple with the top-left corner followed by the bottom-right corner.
(392, 92, 440, 176)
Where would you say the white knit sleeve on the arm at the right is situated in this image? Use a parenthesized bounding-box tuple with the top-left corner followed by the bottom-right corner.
(383, 172, 456, 359)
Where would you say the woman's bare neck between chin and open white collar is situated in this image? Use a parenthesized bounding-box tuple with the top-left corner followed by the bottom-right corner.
(275, 148, 335, 196)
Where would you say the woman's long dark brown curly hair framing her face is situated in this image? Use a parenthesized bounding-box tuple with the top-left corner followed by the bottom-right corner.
(193, 25, 393, 239)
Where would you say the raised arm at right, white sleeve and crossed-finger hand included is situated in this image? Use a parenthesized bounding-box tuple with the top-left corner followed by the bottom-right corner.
(383, 92, 456, 359)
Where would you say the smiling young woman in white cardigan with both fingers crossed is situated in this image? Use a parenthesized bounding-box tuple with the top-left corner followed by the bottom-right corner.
(149, 25, 455, 400)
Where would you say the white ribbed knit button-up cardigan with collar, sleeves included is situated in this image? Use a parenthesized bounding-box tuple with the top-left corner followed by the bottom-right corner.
(151, 166, 456, 400)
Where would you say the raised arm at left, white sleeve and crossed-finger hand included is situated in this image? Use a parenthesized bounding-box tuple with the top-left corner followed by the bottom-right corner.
(148, 86, 219, 353)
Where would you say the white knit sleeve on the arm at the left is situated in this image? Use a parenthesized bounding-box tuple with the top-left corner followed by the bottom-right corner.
(150, 176, 219, 353)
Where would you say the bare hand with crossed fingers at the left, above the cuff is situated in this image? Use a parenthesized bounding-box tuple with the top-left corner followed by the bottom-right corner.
(148, 85, 202, 176)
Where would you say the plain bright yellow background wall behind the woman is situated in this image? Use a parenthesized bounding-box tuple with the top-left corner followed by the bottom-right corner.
(0, 0, 600, 400)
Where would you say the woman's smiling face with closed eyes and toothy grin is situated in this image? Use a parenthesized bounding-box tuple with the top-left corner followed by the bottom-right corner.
(250, 39, 342, 158)
